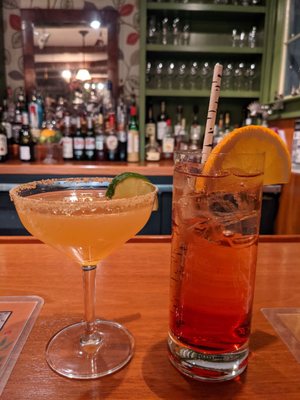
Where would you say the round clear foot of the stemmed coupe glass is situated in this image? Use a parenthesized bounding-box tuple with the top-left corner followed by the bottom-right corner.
(46, 320, 134, 379)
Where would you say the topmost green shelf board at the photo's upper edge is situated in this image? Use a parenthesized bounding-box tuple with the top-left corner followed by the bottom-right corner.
(147, 2, 266, 14)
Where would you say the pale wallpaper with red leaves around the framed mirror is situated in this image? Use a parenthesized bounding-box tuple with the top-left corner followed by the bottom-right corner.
(2, 0, 139, 100)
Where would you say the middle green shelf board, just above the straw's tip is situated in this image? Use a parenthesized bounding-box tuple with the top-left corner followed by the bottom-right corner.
(146, 44, 263, 54)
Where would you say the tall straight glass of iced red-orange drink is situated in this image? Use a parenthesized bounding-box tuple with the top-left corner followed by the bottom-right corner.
(168, 151, 264, 381)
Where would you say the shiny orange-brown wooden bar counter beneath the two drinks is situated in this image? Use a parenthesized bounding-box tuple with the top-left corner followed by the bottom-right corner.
(0, 237, 300, 400)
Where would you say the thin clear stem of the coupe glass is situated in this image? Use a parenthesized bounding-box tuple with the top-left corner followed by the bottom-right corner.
(80, 265, 101, 346)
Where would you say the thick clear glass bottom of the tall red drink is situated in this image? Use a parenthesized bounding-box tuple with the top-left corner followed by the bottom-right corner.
(168, 334, 249, 382)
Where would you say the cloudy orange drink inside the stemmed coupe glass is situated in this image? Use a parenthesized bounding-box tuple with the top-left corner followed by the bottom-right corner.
(18, 189, 151, 265)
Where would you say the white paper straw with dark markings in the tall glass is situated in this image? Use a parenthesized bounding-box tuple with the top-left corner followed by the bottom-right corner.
(201, 63, 223, 163)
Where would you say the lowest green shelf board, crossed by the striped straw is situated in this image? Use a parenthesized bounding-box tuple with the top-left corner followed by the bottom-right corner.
(146, 89, 260, 99)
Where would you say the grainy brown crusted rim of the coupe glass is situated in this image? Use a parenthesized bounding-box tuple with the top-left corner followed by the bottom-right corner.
(9, 177, 158, 209)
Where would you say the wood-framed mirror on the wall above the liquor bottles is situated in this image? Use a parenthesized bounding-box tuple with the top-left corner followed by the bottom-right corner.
(21, 8, 118, 98)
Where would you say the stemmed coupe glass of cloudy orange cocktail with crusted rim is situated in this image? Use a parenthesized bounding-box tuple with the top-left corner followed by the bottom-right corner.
(10, 178, 156, 379)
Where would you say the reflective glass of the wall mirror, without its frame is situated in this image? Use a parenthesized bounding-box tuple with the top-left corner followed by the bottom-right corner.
(33, 25, 108, 96)
